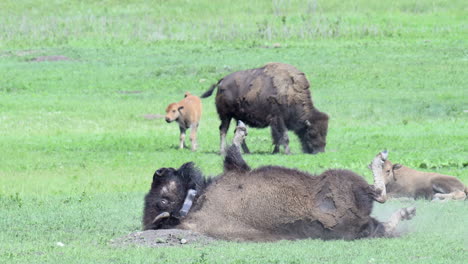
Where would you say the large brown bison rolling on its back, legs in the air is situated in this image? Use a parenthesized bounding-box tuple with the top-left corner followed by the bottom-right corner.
(143, 125, 416, 241)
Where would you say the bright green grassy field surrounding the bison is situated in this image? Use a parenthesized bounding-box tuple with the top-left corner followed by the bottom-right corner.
(0, 0, 468, 264)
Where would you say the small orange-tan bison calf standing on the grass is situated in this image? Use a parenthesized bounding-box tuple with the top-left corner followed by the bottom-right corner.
(166, 92, 202, 151)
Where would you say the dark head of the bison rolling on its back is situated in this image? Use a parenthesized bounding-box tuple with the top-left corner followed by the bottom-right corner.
(143, 162, 204, 230)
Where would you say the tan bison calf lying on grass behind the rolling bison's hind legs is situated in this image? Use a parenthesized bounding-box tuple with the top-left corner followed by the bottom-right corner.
(372, 153, 468, 200)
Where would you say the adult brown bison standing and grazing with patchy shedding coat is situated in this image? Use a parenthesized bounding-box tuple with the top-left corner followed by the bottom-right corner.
(201, 63, 328, 154)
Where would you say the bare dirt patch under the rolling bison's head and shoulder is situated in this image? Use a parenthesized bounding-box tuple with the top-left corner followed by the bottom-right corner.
(110, 229, 215, 247)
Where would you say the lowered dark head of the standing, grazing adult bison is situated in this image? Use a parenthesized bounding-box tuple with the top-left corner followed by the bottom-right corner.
(298, 113, 328, 154)
